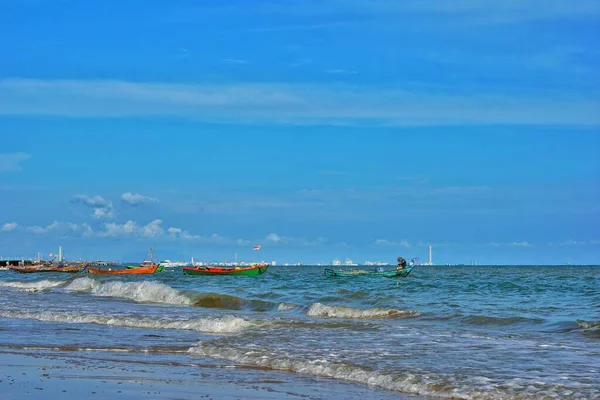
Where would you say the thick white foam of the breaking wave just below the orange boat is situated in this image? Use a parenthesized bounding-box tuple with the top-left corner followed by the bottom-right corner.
(65, 278, 193, 305)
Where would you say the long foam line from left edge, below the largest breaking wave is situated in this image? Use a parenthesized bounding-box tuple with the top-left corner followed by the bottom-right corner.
(0, 310, 252, 333)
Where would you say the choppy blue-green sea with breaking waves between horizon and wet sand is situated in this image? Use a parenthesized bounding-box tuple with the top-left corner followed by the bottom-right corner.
(0, 265, 600, 399)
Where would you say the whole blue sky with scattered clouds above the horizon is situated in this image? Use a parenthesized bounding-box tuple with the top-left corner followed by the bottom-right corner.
(0, 0, 600, 264)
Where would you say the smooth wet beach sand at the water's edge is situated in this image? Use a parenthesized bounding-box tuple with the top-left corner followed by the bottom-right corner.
(0, 349, 416, 400)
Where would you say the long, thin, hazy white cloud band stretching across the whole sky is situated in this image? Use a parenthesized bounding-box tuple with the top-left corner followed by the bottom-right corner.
(0, 79, 600, 126)
